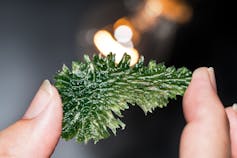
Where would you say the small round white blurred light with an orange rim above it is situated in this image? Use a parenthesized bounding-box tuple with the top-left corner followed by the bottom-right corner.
(114, 25, 133, 43)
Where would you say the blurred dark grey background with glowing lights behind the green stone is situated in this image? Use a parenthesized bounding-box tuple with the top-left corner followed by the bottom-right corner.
(0, 0, 237, 158)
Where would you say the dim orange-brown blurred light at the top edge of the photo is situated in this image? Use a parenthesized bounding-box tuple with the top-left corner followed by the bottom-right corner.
(130, 0, 192, 32)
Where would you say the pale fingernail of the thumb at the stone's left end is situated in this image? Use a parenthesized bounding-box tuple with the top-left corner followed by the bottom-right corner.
(23, 80, 53, 119)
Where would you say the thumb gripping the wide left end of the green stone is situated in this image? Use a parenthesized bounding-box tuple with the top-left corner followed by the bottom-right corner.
(0, 80, 62, 157)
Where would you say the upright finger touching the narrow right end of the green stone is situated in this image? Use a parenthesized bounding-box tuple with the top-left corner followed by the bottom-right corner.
(180, 68, 230, 158)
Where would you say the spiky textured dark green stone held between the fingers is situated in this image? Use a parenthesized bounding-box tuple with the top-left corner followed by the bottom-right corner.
(55, 54, 192, 143)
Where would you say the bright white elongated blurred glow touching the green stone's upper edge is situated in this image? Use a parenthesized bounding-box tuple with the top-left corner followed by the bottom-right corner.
(94, 30, 139, 66)
